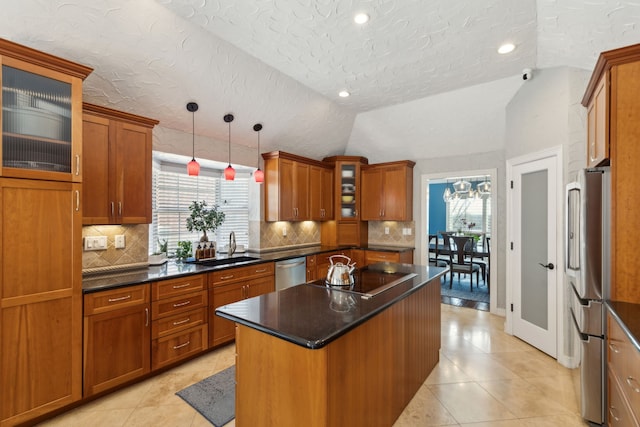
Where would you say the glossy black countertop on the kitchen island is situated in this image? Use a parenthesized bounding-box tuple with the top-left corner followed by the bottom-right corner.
(216, 263, 446, 349)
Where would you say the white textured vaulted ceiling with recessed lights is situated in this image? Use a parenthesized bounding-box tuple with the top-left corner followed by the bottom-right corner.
(0, 0, 640, 160)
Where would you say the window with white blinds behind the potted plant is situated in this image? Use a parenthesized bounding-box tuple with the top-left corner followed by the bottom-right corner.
(149, 162, 250, 254)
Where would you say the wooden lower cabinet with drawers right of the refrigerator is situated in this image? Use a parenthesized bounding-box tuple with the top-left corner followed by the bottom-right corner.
(607, 313, 640, 427)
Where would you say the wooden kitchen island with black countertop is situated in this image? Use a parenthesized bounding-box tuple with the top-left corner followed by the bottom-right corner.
(216, 263, 446, 426)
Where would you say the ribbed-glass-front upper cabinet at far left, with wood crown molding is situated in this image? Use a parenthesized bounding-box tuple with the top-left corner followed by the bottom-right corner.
(0, 41, 90, 182)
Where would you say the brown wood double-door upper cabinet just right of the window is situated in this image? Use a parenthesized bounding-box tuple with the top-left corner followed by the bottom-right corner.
(262, 151, 333, 221)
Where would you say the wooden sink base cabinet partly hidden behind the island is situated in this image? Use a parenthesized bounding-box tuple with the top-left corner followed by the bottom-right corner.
(209, 262, 276, 347)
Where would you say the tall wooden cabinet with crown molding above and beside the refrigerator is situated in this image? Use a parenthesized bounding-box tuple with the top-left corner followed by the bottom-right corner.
(582, 44, 640, 303)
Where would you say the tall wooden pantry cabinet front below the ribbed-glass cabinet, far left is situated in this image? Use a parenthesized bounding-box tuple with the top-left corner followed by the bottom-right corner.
(0, 178, 82, 425)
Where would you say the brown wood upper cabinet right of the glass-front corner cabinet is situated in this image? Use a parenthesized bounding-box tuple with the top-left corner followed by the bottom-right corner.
(361, 160, 415, 221)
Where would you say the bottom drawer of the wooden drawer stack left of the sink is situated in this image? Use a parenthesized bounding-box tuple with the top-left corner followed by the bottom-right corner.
(151, 325, 208, 369)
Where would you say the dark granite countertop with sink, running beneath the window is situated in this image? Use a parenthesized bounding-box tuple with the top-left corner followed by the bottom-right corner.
(82, 245, 413, 293)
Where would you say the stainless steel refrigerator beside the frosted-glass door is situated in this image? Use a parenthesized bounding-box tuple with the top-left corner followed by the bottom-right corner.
(565, 168, 611, 424)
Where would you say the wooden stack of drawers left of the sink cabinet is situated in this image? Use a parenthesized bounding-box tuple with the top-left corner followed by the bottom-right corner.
(151, 274, 209, 369)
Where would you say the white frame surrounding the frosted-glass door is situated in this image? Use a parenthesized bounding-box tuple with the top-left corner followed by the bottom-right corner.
(504, 145, 565, 363)
